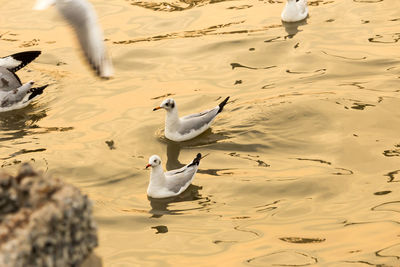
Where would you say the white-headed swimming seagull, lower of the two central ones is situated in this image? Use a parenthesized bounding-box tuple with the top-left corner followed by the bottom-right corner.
(146, 153, 202, 198)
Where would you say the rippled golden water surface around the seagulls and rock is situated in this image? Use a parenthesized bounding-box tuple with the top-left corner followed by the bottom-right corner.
(0, 0, 400, 266)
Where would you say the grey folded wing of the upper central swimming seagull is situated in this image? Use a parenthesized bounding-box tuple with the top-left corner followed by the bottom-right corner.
(178, 106, 220, 134)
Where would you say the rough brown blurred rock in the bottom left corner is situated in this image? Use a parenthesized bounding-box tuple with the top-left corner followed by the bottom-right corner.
(0, 164, 98, 267)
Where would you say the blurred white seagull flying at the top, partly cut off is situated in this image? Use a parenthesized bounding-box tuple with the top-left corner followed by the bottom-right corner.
(33, 0, 113, 78)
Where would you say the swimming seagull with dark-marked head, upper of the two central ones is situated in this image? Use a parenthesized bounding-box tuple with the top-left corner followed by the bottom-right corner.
(153, 96, 229, 142)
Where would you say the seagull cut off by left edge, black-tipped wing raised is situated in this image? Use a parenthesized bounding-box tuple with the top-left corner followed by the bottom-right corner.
(0, 51, 47, 112)
